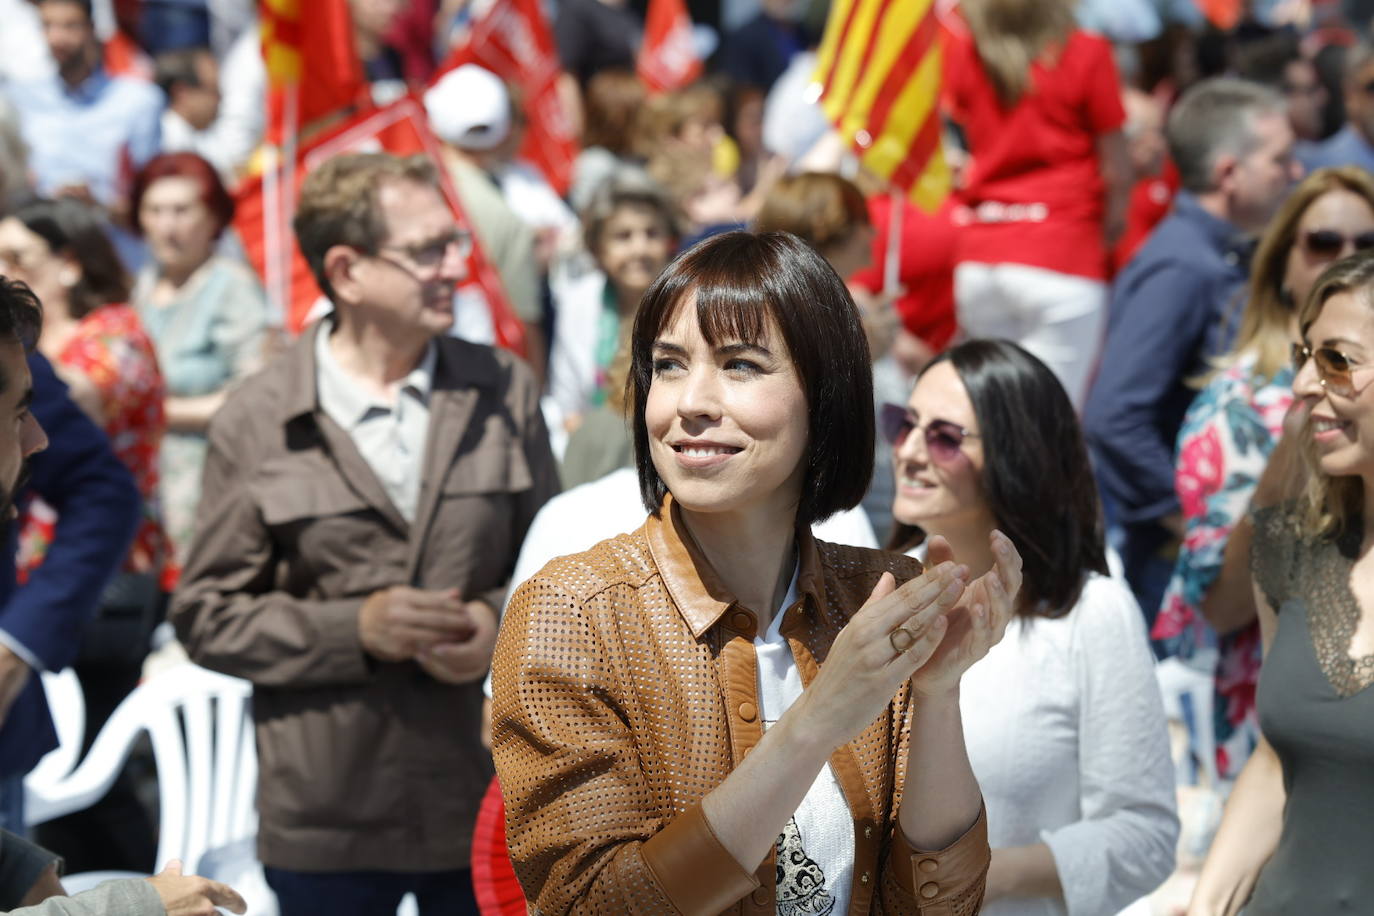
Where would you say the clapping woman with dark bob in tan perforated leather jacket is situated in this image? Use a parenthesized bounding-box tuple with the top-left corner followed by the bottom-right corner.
(492, 232, 1021, 913)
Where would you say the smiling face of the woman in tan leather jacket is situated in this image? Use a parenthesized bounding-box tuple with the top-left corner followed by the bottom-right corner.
(644, 295, 808, 521)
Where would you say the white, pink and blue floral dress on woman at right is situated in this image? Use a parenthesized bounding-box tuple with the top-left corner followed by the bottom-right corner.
(1151, 357, 1293, 779)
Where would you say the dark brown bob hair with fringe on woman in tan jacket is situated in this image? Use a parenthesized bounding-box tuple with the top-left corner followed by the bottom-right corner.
(625, 232, 874, 525)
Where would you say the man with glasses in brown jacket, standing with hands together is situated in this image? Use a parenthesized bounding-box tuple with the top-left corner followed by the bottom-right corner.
(172, 154, 558, 916)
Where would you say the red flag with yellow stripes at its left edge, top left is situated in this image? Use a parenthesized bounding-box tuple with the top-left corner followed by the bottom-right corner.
(258, 0, 367, 144)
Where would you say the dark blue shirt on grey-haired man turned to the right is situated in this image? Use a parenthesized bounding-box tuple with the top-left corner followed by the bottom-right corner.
(1083, 191, 1253, 525)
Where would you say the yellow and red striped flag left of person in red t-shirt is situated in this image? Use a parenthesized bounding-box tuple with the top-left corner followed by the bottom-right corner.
(816, 0, 951, 211)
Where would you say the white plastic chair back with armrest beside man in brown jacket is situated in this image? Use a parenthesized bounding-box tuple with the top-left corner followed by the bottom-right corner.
(29, 663, 257, 871)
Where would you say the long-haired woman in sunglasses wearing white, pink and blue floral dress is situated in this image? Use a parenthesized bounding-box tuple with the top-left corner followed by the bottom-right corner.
(1151, 166, 1374, 780)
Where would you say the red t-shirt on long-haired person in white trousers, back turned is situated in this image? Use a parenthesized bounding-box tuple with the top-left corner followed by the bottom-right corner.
(944, 30, 1125, 279)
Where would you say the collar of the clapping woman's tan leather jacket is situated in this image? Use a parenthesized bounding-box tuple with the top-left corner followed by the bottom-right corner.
(644, 493, 826, 639)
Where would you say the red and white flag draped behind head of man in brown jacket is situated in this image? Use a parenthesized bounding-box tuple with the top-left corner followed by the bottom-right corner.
(234, 96, 525, 354)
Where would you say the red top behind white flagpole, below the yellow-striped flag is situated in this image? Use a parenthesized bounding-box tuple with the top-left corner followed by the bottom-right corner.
(849, 194, 958, 353)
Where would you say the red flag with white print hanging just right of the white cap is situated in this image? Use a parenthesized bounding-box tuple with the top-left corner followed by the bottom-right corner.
(434, 0, 577, 194)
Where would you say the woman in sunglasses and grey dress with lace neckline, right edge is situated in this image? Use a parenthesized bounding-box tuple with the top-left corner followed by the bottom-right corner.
(1189, 253, 1374, 916)
